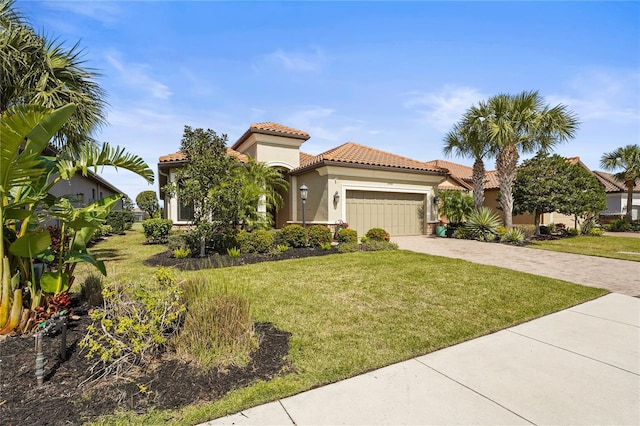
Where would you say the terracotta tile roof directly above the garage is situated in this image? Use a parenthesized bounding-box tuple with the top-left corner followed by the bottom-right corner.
(295, 142, 446, 174)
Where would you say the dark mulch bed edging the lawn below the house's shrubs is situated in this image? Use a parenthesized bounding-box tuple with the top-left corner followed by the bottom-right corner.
(143, 247, 338, 270)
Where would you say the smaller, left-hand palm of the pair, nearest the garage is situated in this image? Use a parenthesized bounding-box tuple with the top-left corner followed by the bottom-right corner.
(443, 106, 490, 210)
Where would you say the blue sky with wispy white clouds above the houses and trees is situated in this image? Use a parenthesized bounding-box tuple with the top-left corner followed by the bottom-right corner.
(16, 0, 640, 203)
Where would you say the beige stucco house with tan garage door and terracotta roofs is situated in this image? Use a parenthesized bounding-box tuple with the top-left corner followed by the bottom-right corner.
(158, 123, 447, 235)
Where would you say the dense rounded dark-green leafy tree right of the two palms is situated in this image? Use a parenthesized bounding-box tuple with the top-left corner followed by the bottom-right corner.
(513, 152, 606, 235)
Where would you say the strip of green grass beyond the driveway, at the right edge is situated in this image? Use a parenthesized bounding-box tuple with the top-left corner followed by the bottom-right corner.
(527, 235, 640, 262)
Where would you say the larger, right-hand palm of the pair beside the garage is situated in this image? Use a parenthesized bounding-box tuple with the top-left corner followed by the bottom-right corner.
(471, 92, 579, 228)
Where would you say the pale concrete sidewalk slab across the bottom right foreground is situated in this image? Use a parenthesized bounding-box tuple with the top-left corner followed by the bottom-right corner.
(205, 294, 640, 425)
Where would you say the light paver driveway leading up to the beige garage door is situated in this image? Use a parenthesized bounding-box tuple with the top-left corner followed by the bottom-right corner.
(392, 235, 640, 297)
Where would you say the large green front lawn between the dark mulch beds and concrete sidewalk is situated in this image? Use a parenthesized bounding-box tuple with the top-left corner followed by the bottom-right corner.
(86, 230, 606, 425)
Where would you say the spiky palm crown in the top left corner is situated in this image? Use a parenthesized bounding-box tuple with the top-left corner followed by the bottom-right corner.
(0, 0, 106, 151)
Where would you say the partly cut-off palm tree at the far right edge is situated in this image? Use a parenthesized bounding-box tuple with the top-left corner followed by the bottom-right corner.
(600, 144, 640, 221)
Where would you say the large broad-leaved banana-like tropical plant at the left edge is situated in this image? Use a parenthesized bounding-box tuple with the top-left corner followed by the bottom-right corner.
(0, 105, 153, 329)
